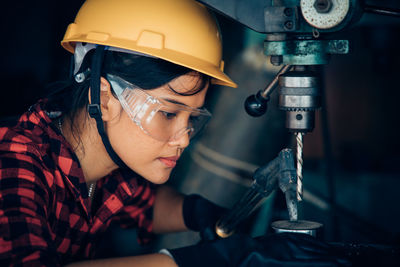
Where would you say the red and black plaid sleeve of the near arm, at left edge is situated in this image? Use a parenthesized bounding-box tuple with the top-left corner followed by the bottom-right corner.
(0, 148, 60, 266)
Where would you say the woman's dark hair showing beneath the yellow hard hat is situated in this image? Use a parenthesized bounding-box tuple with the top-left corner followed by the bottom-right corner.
(45, 50, 210, 148)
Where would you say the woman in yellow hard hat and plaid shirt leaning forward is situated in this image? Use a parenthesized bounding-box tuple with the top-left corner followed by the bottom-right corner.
(0, 0, 348, 266)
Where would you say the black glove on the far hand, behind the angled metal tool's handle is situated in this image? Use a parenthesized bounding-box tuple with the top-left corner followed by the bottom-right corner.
(183, 194, 227, 241)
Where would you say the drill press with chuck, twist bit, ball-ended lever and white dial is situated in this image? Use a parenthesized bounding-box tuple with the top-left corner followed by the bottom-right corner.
(198, 0, 400, 239)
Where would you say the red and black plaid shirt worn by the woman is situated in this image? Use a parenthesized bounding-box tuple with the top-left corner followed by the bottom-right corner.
(0, 101, 155, 266)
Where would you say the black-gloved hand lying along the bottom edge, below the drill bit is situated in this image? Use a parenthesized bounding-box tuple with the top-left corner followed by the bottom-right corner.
(169, 233, 350, 267)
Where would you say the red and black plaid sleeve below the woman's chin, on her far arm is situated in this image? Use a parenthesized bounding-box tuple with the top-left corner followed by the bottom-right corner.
(118, 173, 155, 244)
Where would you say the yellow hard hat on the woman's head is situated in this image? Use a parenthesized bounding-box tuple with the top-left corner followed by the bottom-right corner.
(61, 0, 236, 87)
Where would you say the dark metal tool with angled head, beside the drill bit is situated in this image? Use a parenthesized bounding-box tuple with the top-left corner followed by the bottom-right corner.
(215, 149, 297, 238)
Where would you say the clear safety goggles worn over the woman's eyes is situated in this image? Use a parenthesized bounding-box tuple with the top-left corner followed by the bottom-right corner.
(106, 74, 211, 142)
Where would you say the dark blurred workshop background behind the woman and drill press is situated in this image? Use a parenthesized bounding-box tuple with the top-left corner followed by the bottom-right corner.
(0, 0, 400, 260)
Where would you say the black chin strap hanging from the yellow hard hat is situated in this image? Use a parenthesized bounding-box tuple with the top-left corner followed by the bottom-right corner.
(88, 45, 127, 168)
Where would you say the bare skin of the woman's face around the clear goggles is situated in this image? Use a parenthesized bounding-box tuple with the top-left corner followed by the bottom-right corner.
(107, 72, 208, 184)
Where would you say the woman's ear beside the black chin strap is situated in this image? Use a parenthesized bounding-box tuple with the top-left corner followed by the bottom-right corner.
(89, 77, 121, 122)
